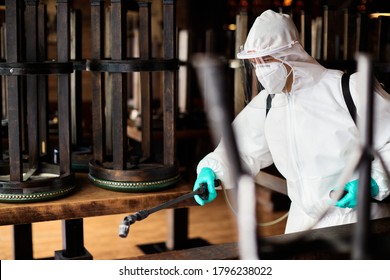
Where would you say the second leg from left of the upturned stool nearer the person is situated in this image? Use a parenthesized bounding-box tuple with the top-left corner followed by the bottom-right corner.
(111, 0, 127, 170)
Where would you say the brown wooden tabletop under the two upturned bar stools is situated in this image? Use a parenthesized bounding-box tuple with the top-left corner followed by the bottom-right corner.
(0, 174, 197, 225)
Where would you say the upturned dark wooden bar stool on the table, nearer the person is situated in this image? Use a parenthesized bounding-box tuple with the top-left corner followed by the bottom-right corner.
(86, 0, 180, 192)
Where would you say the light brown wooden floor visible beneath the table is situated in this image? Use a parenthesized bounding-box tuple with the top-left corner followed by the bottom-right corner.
(0, 190, 286, 260)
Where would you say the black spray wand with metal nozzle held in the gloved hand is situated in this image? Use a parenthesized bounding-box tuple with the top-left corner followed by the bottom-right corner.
(119, 180, 221, 238)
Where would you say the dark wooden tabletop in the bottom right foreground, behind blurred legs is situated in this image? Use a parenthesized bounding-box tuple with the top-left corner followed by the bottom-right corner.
(130, 218, 390, 260)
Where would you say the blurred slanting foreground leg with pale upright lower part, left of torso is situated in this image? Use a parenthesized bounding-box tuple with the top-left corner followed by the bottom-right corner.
(193, 54, 258, 259)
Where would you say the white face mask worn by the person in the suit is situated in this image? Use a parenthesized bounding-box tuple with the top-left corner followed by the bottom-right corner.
(255, 62, 290, 94)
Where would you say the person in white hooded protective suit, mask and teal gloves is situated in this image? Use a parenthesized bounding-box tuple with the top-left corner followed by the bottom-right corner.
(194, 10, 390, 233)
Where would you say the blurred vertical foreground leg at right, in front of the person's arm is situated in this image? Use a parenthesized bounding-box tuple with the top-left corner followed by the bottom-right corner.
(352, 54, 374, 259)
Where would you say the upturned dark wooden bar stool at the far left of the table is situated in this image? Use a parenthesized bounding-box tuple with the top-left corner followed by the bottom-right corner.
(0, 0, 75, 202)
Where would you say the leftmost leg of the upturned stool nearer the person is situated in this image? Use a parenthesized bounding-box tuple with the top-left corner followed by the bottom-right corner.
(91, 0, 106, 162)
